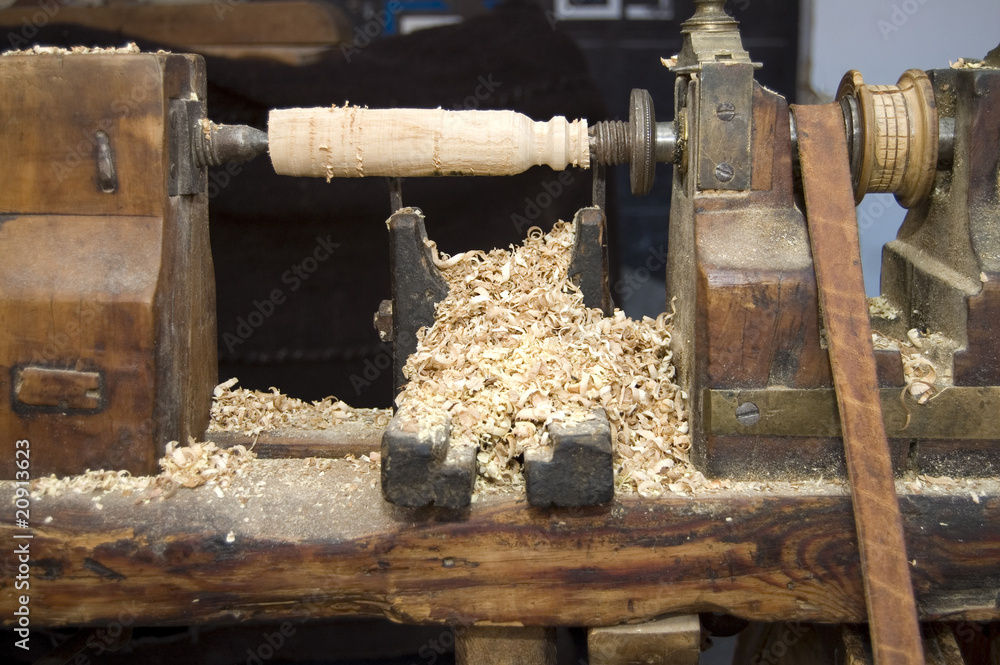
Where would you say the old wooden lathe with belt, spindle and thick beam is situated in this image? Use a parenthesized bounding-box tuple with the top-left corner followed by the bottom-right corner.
(0, 0, 1000, 665)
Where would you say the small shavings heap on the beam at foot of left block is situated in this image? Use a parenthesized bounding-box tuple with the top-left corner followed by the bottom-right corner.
(31, 439, 257, 498)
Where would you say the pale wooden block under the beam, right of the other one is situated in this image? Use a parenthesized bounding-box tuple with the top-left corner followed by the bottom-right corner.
(587, 614, 701, 665)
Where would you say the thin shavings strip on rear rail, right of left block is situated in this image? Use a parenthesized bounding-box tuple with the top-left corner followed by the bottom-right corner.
(208, 379, 390, 440)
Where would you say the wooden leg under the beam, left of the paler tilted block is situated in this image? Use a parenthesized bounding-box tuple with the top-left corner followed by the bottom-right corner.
(455, 626, 556, 665)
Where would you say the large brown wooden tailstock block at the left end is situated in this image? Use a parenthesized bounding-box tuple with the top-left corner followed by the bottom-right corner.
(0, 53, 217, 477)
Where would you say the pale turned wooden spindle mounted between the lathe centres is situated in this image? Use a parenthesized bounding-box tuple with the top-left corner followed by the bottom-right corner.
(268, 106, 590, 181)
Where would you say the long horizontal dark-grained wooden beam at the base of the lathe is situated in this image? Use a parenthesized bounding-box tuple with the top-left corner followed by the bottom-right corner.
(0, 460, 1000, 626)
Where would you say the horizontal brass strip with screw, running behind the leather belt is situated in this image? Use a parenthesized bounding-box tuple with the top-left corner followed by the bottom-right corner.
(704, 386, 1000, 441)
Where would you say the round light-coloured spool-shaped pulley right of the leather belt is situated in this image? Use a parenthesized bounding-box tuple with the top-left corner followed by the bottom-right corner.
(837, 69, 939, 208)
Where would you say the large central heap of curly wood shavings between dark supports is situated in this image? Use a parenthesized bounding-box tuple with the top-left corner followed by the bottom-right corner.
(396, 222, 710, 497)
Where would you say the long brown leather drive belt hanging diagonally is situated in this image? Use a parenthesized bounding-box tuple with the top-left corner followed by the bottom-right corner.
(793, 104, 924, 665)
